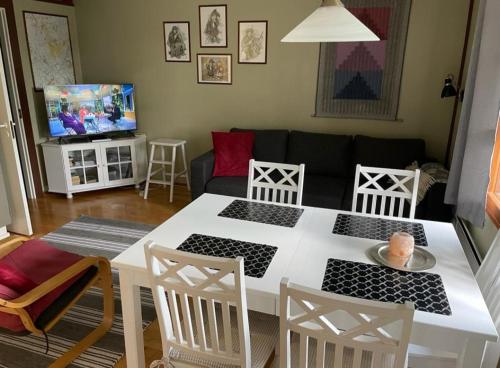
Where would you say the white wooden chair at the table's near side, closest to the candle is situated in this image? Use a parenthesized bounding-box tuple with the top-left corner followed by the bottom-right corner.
(279, 279, 414, 368)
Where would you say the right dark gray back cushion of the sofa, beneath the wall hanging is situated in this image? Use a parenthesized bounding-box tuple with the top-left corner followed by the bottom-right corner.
(352, 135, 425, 175)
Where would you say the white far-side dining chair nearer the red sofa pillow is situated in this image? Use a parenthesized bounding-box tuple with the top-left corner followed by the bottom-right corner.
(247, 159, 305, 206)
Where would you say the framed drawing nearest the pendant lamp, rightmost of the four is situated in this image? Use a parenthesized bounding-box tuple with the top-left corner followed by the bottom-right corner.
(238, 20, 267, 64)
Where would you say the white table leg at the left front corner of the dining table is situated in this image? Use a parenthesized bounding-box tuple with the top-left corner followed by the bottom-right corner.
(120, 270, 146, 368)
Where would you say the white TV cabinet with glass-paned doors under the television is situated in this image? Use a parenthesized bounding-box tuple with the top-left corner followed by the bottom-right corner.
(42, 135, 147, 199)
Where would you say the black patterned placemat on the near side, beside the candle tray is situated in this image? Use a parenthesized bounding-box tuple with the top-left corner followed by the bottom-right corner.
(321, 258, 451, 316)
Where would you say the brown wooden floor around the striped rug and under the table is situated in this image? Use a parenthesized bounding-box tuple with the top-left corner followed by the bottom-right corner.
(29, 185, 191, 368)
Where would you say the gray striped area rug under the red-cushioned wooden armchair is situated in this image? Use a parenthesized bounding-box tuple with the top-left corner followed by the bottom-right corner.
(0, 216, 156, 368)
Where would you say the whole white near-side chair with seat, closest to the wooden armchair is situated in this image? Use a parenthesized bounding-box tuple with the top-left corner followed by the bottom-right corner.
(145, 242, 279, 368)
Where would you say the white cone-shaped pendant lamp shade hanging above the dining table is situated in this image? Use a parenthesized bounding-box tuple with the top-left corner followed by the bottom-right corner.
(281, 0, 380, 42)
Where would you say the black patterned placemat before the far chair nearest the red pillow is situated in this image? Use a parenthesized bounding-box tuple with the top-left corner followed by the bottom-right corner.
(219, 199, 304, 227)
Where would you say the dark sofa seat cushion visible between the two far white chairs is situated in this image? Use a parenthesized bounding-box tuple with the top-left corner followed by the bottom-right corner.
(302, 175, 347, 209)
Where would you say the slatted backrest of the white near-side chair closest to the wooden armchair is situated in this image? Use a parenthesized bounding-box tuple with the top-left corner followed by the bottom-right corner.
(145, 242, 251, 368)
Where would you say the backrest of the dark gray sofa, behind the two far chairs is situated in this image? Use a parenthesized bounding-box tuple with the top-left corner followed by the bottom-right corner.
(227, 128, 426, 177)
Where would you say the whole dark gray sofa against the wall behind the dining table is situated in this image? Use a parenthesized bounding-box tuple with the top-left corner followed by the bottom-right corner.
(191, 128, 452, 221)
